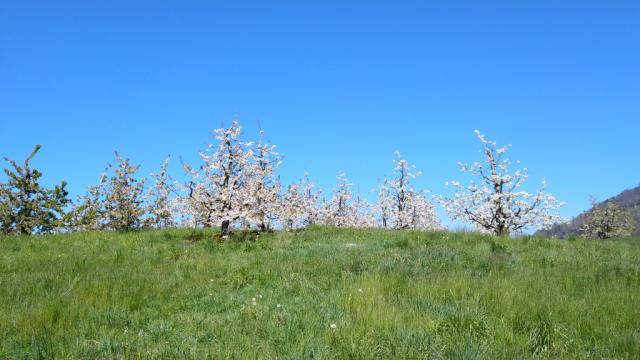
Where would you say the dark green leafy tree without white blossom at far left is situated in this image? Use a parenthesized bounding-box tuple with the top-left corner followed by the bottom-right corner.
(0, 145, 69, 234)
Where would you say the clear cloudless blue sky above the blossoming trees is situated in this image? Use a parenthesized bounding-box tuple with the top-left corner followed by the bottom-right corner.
(0, 0, 640, 224)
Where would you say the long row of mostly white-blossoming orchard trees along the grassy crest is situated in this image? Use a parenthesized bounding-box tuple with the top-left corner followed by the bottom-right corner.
(6, 121, 624, 237)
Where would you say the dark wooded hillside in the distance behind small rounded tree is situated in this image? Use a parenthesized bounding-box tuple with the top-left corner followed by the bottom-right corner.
(537, 185, 640, 238)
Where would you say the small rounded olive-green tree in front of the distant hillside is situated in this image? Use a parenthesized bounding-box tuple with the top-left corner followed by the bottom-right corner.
(582, 201, 636, 239)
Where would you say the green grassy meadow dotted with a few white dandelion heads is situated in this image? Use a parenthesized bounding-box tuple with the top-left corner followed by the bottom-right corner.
(0, 227, 640, 359)
